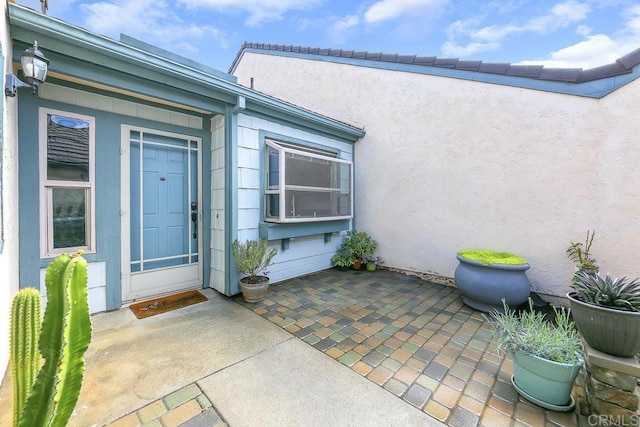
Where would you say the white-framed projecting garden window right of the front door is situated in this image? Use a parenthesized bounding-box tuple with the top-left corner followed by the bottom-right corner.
(265, 139, 353, 222)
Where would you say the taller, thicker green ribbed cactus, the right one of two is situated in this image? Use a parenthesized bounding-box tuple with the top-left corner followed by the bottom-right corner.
(10, 252, 91, 427)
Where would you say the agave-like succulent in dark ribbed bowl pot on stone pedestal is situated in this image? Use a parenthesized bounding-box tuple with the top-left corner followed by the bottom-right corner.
(567, 270, 640, 357)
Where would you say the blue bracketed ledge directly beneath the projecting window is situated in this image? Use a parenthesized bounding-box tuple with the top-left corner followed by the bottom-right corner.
(259, 219, 350, 251)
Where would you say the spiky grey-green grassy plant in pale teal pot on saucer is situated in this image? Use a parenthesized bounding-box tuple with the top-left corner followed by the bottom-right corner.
(489, 298, 584, 411)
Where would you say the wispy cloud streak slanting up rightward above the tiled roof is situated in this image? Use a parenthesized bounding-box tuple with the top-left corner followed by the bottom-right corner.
(442, 0, 591, 56)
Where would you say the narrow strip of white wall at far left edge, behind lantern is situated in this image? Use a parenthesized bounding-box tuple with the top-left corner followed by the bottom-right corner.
(0, 2, 18, 379)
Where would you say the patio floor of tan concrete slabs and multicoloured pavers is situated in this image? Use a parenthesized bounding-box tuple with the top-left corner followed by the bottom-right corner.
(0, 270, 577, 427)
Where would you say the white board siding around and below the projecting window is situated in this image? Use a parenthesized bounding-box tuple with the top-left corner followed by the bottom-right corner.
(238, 114, 353, 283)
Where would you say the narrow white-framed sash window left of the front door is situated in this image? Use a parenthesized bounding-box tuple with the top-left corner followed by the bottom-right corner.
(40, 109, 95, 257)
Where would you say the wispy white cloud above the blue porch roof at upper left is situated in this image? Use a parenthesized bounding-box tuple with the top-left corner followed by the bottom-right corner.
(80, 0, 228, 54)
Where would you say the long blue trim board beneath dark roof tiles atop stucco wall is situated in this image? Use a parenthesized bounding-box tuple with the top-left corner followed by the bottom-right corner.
(232, 47, 640, 99)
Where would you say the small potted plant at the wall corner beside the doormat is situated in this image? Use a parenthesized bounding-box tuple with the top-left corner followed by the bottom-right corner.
(231, 239, 278, 303)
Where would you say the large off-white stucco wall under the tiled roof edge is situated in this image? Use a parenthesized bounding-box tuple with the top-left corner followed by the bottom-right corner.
(234, 53, 640, 295)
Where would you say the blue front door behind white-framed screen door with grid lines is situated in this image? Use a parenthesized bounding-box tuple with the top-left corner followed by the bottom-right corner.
(123, 128, 202, 301)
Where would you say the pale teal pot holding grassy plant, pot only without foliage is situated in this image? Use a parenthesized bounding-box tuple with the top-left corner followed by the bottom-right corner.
(513, 350, 584, 410)
